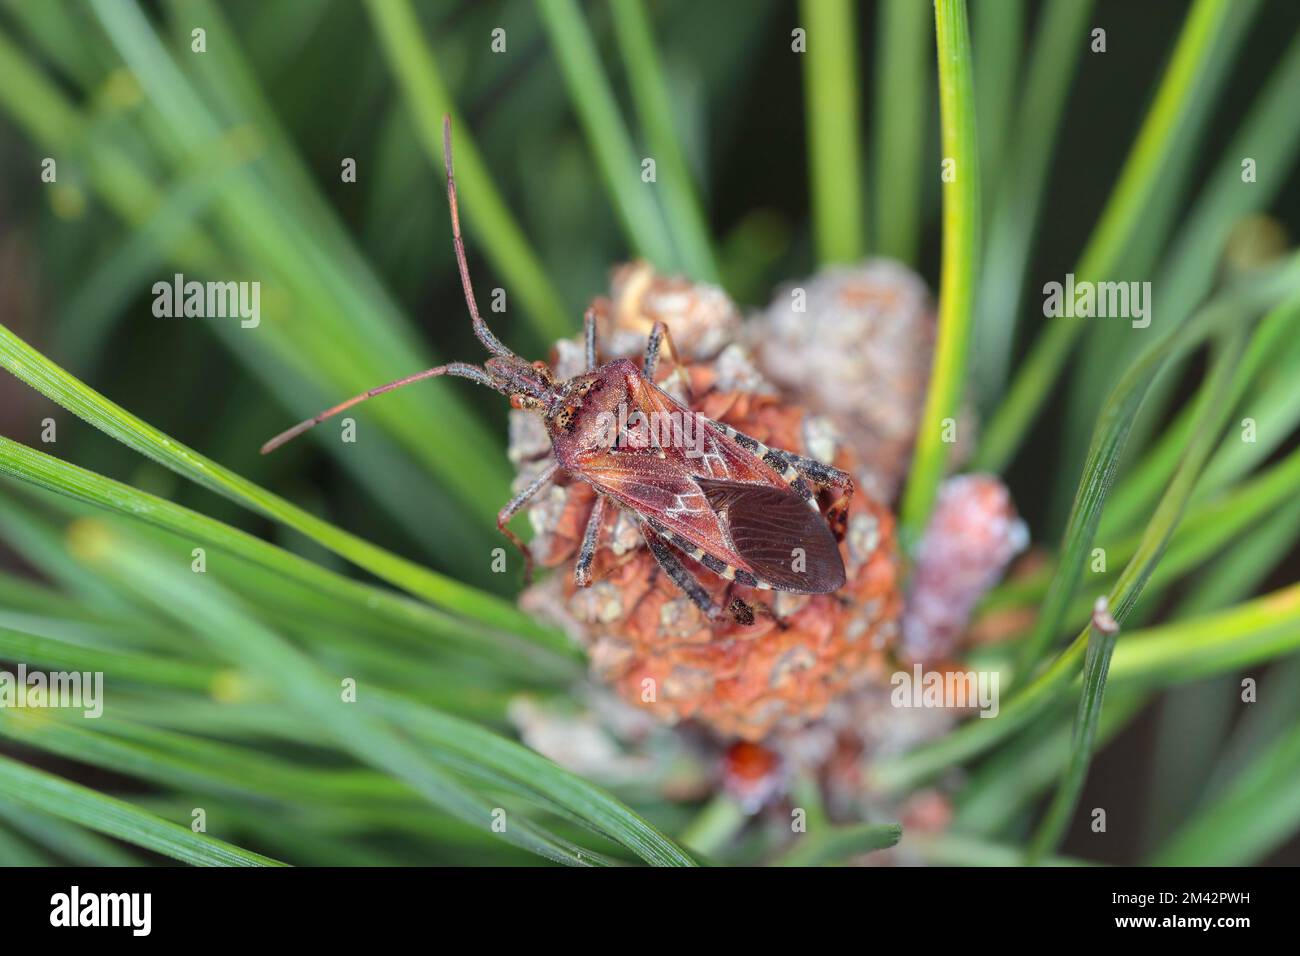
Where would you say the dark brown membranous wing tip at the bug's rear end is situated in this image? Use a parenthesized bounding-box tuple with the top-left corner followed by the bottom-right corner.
(696, 477, 845, 594)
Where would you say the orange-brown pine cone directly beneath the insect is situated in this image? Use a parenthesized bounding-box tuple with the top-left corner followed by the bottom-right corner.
(511, 264, 902, 740)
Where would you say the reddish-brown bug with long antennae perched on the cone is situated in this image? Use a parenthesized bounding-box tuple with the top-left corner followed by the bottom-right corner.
(261, 117, 853, 624)
